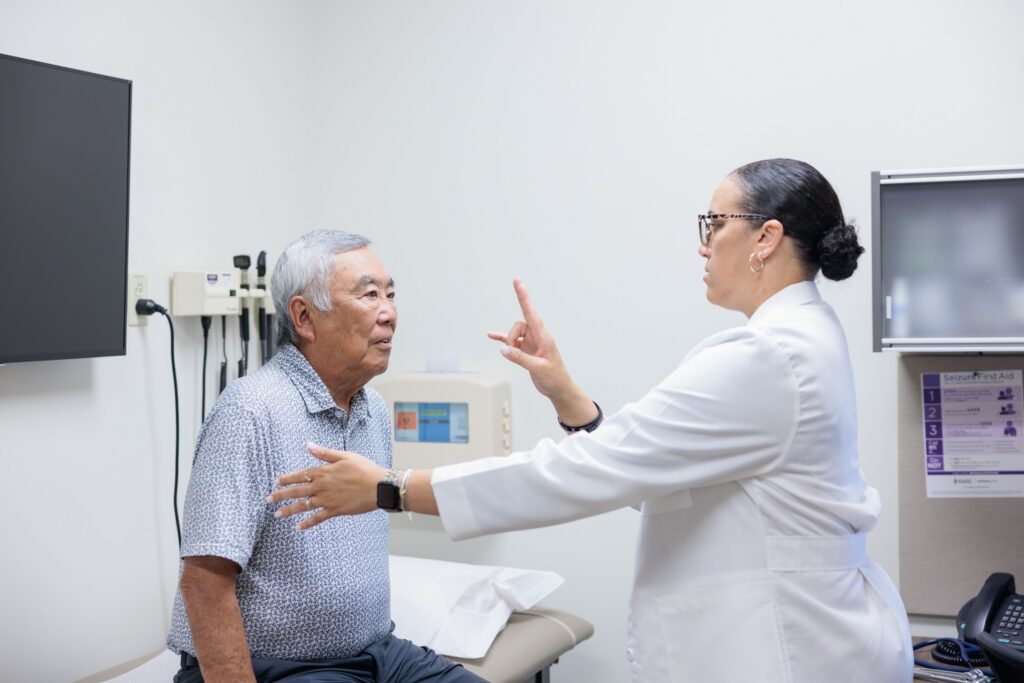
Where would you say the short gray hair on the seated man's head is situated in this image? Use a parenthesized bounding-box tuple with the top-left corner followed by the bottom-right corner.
(270, 230, 370, 345)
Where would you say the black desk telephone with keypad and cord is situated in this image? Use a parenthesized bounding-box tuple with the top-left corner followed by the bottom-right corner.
(932, 573, 1024, 683)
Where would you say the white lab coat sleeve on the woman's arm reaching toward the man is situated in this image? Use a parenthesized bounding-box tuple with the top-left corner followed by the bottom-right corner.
(431, 328, 799, 539)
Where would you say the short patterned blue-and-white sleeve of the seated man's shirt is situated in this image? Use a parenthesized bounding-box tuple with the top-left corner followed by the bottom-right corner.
(181, 403, 271, 568)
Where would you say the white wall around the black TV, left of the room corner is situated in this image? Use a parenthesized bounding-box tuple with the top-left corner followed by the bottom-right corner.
(0, 0, 315, 683)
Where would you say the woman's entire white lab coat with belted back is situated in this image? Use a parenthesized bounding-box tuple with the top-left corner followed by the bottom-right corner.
(432, 282, 912, 683)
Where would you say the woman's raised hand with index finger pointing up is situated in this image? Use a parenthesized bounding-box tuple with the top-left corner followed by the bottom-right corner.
(487, 278, 597, 425)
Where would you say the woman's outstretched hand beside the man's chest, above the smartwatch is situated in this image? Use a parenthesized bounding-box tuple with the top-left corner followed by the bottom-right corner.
(266, 443, 387, 529)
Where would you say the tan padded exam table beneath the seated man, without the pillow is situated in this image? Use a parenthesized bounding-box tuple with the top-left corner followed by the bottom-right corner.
(76, 607, 594, 683)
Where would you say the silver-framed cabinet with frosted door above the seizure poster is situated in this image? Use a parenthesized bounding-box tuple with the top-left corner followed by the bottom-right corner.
(872, 166, 1024, 353)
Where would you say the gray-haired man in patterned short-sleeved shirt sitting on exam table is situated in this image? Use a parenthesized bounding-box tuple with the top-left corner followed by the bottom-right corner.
(168, 230, 481, 683)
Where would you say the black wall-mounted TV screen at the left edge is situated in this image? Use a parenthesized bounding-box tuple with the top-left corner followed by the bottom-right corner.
(0, 54, 131, 364)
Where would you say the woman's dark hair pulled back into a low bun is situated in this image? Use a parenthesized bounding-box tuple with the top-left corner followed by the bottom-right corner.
(732, 159, 864, 280)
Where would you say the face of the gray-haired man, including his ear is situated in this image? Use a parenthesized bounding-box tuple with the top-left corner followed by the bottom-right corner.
(311, 248, 398, 383)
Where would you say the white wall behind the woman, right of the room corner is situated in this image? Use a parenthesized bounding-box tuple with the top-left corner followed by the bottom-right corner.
(316, 0, 1024, 682)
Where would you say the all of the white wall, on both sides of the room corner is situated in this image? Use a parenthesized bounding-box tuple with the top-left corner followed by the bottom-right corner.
(0, 0, 1024, 682)
